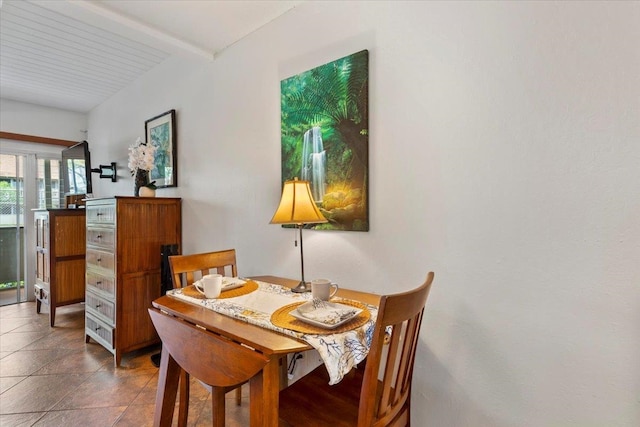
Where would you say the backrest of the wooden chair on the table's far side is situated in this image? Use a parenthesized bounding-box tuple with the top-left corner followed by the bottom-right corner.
(169, 249, 238, 288)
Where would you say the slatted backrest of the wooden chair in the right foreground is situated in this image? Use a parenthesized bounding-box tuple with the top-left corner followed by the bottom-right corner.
(358, 272, 433, 427)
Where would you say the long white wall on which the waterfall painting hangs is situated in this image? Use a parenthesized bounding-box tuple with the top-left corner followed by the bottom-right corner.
(89, 2, 640, 426)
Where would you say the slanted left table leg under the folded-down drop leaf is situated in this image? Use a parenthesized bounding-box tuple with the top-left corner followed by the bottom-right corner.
(153, 346, 182, 427)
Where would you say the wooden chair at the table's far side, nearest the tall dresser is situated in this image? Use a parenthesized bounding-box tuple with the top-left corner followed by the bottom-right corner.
(169, 249, 242, 426)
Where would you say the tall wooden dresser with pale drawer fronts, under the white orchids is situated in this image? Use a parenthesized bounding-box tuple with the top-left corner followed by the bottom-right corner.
(85, 197, 182, 366)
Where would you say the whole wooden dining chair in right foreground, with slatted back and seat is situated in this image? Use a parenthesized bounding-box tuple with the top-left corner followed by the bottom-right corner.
(280, 272, 433, 427)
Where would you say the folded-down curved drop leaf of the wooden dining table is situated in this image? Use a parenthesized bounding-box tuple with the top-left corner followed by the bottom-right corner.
(149, 308, 269, 387)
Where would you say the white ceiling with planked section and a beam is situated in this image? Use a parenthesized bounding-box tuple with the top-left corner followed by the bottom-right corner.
(0, 0, 301, 112)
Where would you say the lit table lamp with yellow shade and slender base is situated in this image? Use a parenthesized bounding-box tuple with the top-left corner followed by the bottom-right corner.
(270, 178, 327, 292)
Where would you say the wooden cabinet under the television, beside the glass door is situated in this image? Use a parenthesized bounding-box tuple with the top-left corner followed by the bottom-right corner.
(34, 209, 85, 326)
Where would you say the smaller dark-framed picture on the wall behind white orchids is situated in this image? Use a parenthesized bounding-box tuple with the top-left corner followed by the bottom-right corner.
(144, 110, 178, 188)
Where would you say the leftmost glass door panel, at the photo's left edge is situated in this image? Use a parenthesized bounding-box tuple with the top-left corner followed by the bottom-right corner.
(0, 154, 27, 305)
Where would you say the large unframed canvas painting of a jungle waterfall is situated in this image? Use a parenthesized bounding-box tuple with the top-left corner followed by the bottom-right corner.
(280, 50, 369, 231)
